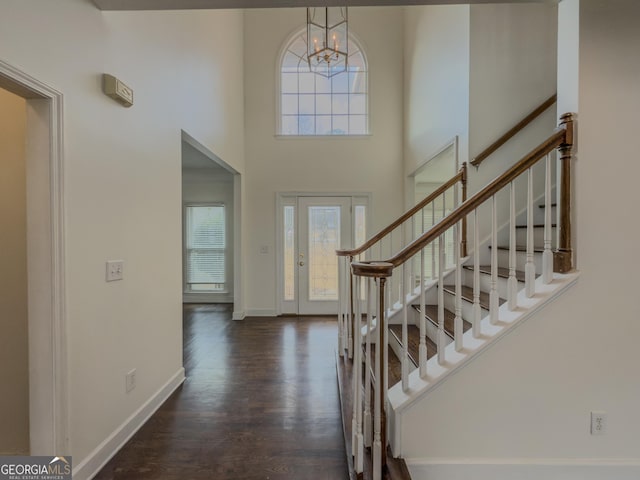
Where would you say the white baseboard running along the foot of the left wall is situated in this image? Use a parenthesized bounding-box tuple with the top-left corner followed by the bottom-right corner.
(73, 368, 185, 480)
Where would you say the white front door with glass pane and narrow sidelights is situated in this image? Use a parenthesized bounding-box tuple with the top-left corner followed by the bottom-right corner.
(278, 194, 369, 315)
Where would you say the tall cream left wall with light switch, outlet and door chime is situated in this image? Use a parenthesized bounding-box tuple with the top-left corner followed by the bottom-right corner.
(0, 0, 244, 465)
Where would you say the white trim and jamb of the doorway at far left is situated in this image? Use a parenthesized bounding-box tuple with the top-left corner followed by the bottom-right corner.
(0, 60, 71, 455)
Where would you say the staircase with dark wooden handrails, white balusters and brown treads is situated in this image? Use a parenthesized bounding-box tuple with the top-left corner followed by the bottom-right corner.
(337, 103, 577, 480)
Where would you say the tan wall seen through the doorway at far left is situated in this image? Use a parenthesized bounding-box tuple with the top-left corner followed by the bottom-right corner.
(0, 88, 29, 455)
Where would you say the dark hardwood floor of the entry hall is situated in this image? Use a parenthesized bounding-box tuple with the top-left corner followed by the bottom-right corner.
(95, 305, 348, 480)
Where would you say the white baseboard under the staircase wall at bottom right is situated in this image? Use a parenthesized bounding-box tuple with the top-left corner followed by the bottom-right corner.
(405, 458, 640, 480)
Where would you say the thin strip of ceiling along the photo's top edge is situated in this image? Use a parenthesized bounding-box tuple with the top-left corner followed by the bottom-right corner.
(92, 0, 559, 10)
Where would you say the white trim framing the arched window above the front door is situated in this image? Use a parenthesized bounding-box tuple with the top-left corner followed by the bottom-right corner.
(273, 27, 373, 140)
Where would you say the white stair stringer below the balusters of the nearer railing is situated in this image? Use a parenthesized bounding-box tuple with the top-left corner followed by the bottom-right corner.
(387, 272, 579, 457)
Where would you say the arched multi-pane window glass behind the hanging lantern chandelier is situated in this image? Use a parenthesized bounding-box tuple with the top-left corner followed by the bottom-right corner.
(279, 29, 369, 135)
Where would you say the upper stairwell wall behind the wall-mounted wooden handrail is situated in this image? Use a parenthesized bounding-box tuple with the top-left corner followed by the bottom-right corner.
(469, 3, 558, 193)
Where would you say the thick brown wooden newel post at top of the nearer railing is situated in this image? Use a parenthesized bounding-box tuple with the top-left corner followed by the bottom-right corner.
(553, 113, 576, 273)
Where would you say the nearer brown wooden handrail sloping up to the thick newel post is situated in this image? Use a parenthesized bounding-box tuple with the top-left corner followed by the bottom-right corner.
(352, 114, 573, 276)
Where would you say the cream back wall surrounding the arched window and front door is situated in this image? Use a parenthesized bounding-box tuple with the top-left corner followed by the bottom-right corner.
(245, 8, 403, 315)
